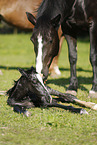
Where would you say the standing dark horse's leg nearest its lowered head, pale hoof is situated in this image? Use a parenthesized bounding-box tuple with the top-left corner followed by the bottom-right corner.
(65, 35, 78, 95)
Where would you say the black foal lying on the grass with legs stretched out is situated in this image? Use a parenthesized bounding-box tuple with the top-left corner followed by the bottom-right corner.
(7, 67, 96, 116)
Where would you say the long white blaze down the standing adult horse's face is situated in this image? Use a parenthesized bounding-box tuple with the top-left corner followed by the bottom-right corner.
(36, 34, 43, 73)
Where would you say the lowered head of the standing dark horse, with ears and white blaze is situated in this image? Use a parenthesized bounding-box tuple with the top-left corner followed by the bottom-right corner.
(27, 13, 60, 80)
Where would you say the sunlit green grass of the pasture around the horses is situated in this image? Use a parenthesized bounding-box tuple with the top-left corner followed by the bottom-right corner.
(0, 34, 97, 145)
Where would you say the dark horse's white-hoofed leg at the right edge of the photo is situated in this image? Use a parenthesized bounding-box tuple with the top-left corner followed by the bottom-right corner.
(89, 21, 97, 98)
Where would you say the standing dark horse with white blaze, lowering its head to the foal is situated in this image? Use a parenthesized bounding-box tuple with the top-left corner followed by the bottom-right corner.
(27, 0, 97, 98)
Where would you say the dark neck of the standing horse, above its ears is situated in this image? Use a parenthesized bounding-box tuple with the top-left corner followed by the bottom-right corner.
(37, 0, 75, 22)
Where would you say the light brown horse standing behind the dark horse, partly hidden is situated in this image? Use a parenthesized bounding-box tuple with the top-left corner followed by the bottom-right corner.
(0, 0, 63, 75)
